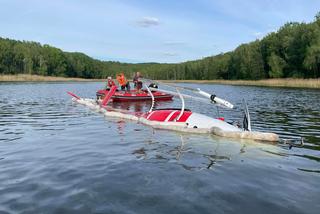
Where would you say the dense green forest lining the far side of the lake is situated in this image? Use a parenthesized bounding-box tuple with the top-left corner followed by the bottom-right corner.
(0, 13, 320, 80)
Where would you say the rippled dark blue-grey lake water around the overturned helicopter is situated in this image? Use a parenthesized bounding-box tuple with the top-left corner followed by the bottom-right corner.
(0, 83, 320, 214)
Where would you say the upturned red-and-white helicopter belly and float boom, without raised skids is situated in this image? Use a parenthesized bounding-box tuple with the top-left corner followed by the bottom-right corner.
(68, 96, 279, 142)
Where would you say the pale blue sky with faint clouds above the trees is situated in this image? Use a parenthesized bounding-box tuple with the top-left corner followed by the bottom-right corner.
(0, 0, 320, 63)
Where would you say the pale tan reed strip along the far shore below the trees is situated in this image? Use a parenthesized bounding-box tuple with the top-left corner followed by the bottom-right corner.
(0, 74, 320, 89)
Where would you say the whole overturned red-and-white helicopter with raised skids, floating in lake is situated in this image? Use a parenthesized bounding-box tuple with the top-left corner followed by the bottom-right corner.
(68, 77, 280, 142)
